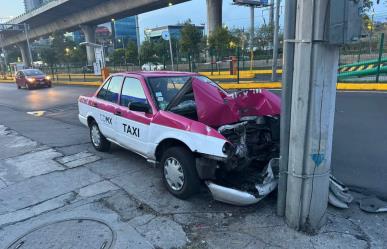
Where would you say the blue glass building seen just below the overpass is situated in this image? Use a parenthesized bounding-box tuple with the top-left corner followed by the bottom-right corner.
(111, 16, 139, 48)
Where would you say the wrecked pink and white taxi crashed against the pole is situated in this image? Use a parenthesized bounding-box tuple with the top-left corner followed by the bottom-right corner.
(78, 72, 280, 205)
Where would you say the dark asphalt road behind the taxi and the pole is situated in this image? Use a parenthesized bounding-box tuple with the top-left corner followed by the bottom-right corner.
(0, 84, 387, 199)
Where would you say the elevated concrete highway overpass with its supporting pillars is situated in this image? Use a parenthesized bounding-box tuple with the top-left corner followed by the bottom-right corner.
(0, 0, 222, 65)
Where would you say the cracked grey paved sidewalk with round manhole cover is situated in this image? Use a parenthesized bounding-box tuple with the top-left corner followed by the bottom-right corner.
(0, 107, 387, 249)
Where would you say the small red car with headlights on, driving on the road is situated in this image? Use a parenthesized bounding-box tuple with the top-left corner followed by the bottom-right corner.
(16, 69, 52, 89)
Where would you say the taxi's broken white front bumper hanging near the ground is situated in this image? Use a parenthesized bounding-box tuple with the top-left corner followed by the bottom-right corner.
(206, 158, 279, 206)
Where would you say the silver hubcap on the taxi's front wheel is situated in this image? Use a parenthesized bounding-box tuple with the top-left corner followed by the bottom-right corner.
(164, 157, 184, 191)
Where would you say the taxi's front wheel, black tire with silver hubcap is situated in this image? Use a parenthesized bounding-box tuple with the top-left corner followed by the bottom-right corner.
(161, 147, 200, 199)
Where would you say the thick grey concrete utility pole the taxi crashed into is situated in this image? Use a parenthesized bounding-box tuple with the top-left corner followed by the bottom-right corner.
(280, 0, 339, 233)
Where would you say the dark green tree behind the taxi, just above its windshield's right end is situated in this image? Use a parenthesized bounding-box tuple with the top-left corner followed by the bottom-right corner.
(180, 20, 203, 58)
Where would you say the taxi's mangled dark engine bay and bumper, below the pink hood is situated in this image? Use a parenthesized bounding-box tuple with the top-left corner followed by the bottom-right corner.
(196, 116, 279, 206)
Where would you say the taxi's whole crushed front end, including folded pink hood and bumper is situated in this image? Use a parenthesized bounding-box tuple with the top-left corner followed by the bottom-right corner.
(169, 77, 281, 205)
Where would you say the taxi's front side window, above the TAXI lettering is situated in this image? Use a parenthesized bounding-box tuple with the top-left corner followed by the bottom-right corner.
(120, 77, 147, 107)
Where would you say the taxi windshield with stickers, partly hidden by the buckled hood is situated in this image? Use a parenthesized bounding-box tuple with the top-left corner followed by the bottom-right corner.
(148, 76, 192, 110)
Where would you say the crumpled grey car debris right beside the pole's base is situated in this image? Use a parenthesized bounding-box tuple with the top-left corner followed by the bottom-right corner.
(328, 175, 353, 209)
